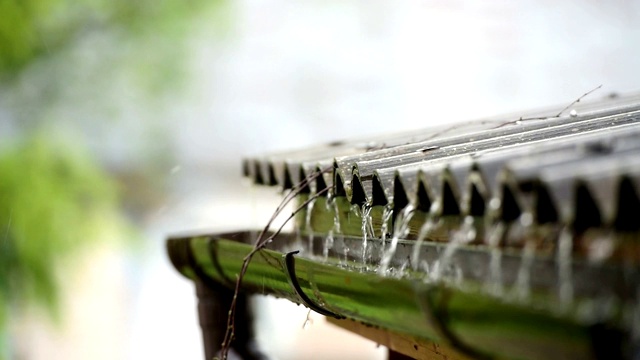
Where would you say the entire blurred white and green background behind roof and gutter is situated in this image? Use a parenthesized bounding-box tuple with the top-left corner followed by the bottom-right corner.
(0, 0, 640, 359)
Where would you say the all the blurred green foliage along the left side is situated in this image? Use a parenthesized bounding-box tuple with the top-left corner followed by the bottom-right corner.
(0, 0, 224, 359)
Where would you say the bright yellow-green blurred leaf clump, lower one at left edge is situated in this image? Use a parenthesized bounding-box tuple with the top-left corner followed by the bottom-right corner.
(0, 133, 124, 329)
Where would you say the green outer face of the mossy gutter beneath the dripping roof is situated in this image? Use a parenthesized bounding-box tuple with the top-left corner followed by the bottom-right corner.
(168, 234, 620, 359)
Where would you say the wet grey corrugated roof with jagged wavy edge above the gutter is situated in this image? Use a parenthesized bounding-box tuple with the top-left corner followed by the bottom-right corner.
(244, 97, 640, 231)
